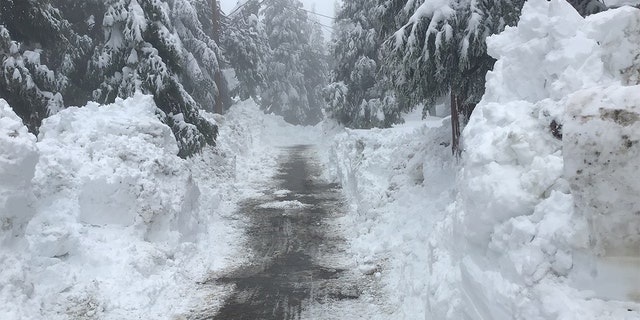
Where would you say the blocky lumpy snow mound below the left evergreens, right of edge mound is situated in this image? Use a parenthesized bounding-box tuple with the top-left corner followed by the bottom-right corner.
(33, 94, 199, 245)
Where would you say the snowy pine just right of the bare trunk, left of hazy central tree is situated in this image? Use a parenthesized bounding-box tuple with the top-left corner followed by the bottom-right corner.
(221, 0, 270, 102)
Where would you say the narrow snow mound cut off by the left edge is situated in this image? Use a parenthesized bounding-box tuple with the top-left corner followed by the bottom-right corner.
(0, 99, 38, 241)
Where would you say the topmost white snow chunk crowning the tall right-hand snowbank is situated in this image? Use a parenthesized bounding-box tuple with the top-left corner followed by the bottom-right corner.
(483, 0, 611, 103)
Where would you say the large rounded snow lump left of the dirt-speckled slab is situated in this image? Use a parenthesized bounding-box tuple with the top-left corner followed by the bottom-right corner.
(460, 101, 562, 244)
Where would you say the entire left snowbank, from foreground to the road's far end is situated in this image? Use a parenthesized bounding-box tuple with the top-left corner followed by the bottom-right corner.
(0, 95, 317, 319)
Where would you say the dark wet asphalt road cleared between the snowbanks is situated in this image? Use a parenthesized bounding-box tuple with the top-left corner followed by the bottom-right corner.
(198, 146, 360, 320)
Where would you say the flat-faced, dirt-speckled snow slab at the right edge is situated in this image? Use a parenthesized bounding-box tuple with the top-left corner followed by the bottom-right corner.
(564, 86, 640, 257)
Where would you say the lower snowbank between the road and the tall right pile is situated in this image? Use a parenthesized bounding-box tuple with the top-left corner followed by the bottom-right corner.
(329, 110, 455, 319)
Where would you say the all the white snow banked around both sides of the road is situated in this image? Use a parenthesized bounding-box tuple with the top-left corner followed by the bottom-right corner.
(0, 0, 640, 319)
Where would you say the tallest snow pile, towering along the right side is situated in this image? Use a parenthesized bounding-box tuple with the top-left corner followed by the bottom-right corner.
(452, 0, 640, 319)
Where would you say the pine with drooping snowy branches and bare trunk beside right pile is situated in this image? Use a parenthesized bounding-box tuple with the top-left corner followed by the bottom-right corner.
(387, 0, 524, 153)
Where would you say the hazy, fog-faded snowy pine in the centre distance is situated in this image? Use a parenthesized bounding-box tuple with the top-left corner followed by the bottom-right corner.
(261, 0, 313, 124)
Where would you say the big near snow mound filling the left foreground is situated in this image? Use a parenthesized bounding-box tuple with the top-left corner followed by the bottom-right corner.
(0, 95, 209, 319)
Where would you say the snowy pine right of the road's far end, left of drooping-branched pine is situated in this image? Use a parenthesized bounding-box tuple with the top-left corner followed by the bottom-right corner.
(325, 0, 404, 128)
